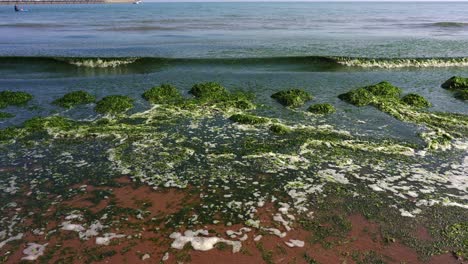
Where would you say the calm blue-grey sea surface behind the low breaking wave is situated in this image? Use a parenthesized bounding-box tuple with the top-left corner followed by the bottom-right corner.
(0, 2, 468, 57)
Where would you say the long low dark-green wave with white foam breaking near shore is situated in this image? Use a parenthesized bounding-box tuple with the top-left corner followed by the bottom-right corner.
(0, 56, 468, 69)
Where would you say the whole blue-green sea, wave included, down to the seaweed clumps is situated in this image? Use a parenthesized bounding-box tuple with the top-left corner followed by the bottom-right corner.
(0, 2, 468, 141)
